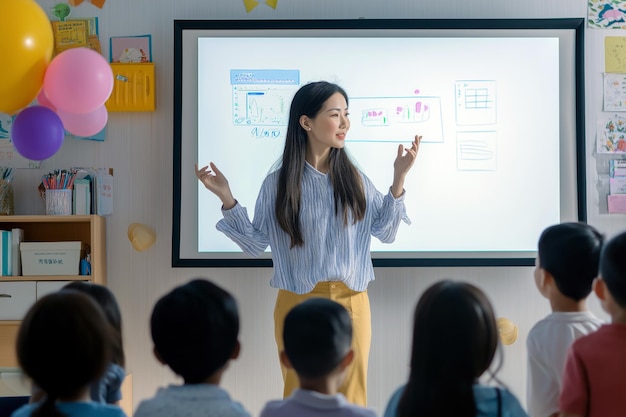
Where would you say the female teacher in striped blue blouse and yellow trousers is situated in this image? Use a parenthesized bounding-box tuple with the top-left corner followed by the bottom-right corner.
(196, 81, 421, 405)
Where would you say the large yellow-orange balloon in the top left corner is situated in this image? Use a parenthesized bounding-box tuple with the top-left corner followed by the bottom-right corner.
(0, 0, 54, 114)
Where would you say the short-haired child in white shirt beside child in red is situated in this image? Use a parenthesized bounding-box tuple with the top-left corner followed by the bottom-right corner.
(526, 223, 604, 417)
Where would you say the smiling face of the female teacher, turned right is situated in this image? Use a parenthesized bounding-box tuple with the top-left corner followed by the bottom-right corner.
(301, 93, 350, 151)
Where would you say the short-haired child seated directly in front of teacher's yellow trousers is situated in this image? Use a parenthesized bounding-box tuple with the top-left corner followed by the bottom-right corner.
(261, 298, 376, 417)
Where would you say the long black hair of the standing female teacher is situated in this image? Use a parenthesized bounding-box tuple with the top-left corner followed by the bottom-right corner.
(276, 81, 365, 248)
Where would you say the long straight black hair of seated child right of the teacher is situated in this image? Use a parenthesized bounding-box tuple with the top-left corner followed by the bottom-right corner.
(398, 280, 498, 416)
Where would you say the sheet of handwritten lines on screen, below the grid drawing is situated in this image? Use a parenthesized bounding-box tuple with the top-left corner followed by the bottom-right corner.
(456, 131, 498, 171)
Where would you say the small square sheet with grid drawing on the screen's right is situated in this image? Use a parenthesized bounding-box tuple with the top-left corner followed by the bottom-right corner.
(454, 80, 497, 126)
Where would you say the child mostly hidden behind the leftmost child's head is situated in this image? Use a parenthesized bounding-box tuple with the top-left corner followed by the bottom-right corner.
(63, 281, 126, 404)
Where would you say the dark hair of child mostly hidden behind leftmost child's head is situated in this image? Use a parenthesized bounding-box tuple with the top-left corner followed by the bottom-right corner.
(63, 281, 126, 367)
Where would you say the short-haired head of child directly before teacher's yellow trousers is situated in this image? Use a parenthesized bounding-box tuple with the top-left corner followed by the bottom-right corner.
(283, 298, 352, 378)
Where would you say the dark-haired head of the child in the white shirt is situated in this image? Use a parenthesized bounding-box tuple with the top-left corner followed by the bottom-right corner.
(538, 223, 604, 301)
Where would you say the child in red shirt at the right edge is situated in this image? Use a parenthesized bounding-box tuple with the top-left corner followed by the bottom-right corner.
(559, 232, 626, 417)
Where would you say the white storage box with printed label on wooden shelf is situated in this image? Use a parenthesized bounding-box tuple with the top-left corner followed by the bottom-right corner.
(20, 242, 88, 275)
